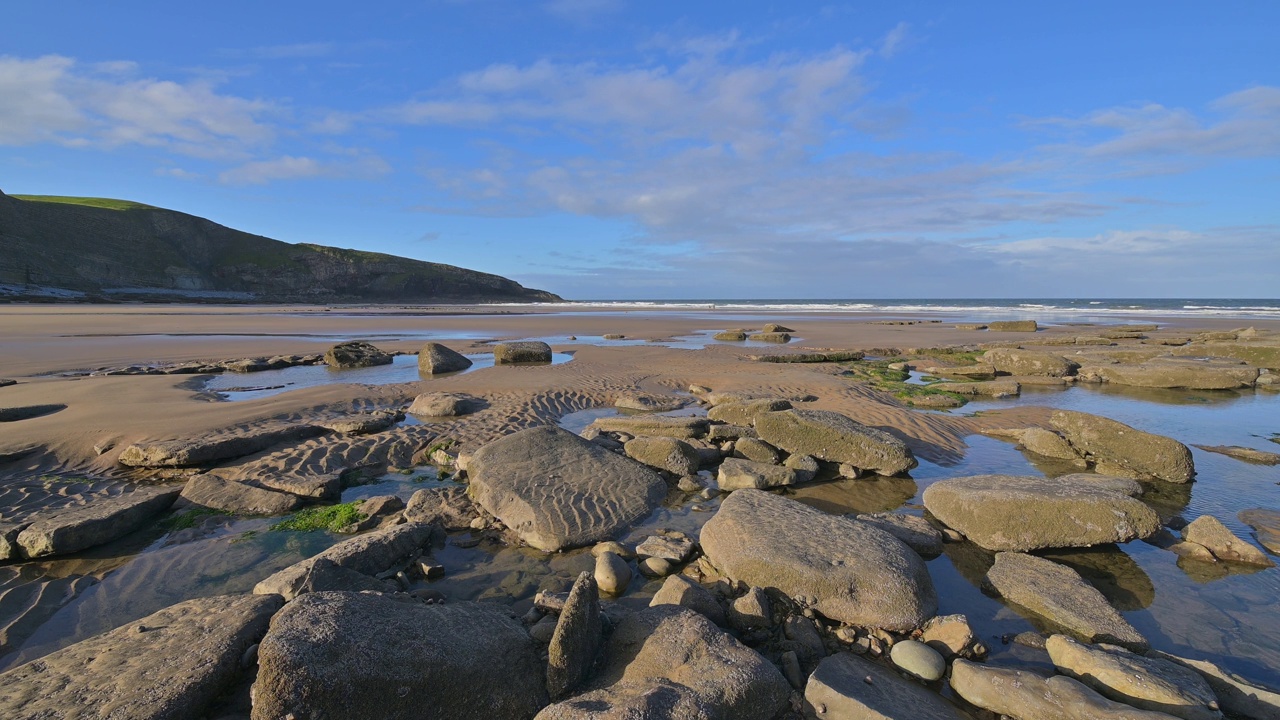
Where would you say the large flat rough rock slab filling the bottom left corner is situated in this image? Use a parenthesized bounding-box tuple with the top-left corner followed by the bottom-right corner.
(0, 594, 284, 720)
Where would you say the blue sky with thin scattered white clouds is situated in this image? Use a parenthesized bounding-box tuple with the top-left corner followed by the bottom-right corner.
(0, 0, 1280, 300)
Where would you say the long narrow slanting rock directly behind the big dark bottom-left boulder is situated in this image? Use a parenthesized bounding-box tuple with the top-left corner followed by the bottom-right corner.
(253, 523, 431, 600)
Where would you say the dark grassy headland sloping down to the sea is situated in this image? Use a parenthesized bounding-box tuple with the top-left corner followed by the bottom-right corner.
(0, 192, 561, 302)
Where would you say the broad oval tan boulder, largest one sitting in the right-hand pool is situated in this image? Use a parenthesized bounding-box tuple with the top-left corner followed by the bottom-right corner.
(924, 475, 1160, 551)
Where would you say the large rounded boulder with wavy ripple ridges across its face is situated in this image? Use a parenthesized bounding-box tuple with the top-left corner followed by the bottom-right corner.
(467, 427, 667, 552)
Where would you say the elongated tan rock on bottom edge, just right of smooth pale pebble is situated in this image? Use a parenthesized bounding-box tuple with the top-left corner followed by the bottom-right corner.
(951, 660, 1171, 720)
